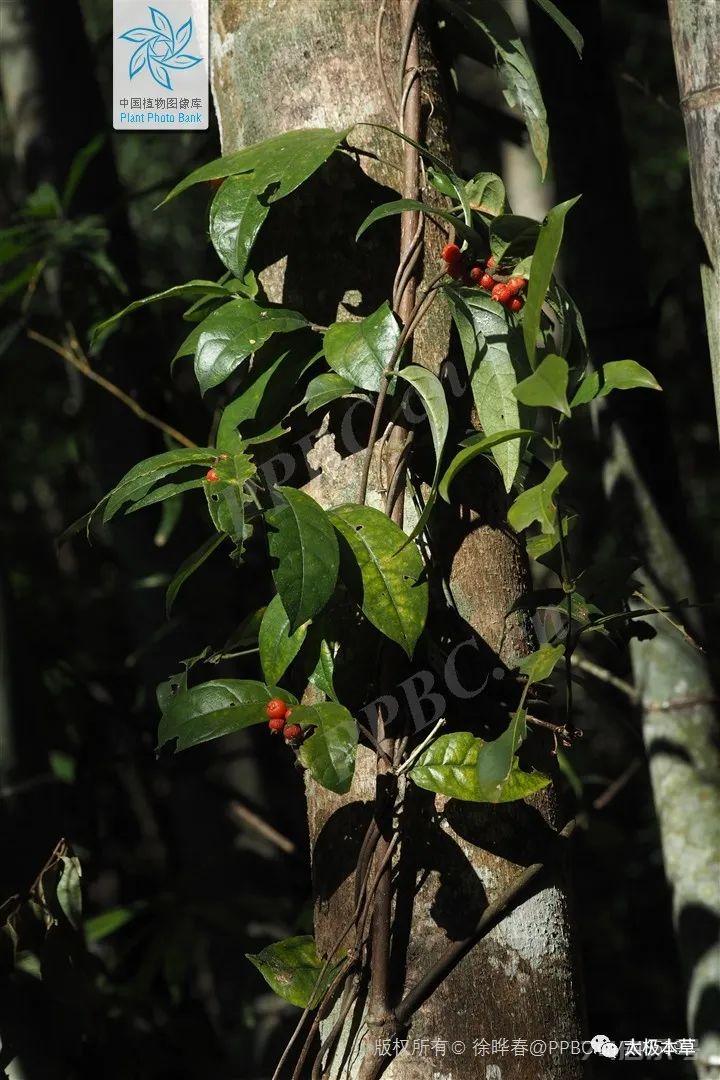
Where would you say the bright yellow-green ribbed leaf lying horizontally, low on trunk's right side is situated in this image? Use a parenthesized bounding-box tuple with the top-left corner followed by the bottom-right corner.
(410, 731, 549, 802)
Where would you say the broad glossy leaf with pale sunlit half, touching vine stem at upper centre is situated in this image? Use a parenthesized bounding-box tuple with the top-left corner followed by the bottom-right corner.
(323, 300, 400, 392)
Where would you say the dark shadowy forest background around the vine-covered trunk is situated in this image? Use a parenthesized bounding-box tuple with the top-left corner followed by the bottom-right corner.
(0, 0, 720, 1080)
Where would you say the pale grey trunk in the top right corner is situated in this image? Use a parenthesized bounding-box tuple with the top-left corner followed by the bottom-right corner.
(667, 0, 720, 442)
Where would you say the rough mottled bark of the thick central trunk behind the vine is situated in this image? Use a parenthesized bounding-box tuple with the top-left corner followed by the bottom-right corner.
(210, 0, 581, 1080)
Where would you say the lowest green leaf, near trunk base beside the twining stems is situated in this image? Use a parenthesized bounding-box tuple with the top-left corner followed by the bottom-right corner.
(245, 935, 338, 1009)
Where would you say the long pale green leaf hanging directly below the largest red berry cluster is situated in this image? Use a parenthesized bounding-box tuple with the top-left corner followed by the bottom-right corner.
(447, 289, 520, 491)
